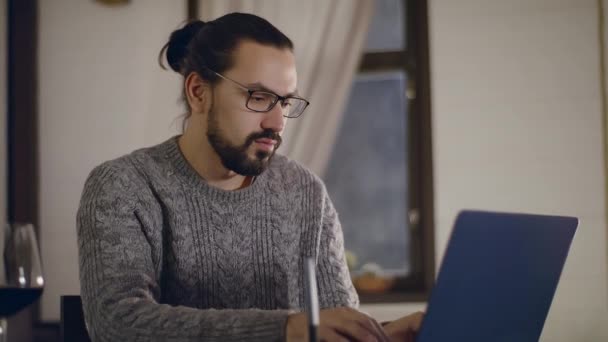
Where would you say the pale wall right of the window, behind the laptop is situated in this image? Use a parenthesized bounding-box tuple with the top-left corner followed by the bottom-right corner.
(372, 0, 608, 341)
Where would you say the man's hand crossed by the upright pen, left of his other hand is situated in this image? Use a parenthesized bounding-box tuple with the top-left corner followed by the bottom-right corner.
(286, 308, 389, 342)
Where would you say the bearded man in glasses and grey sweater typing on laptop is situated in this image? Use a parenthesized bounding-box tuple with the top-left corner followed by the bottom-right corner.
(78, 13, 420, 341)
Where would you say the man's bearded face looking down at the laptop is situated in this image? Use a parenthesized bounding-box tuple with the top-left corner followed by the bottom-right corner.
(207, 41, 297, 176)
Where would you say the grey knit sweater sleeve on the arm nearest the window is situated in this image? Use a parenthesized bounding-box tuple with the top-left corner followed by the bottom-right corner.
(317, 187, 359, 308)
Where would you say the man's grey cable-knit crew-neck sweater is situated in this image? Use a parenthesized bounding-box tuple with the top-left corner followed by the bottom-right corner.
(77, 137, 358, 342)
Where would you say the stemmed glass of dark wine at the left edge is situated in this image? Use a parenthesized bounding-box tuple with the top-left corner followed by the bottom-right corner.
(0, 223, 44, 342)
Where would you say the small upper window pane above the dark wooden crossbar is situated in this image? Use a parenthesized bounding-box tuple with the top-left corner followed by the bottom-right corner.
(364, 0, 405, 52)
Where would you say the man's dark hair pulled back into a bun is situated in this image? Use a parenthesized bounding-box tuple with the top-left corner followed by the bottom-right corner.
(158, 13, 293, 127)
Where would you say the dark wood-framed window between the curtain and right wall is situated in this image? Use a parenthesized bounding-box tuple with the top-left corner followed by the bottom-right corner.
(323, 0, 434, 303)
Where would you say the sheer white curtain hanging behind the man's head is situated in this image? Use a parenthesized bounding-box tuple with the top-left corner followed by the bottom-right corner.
(199, 0, 374, 175)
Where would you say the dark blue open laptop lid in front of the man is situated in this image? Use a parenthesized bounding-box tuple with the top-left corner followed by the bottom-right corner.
(416, 211, 578, 342)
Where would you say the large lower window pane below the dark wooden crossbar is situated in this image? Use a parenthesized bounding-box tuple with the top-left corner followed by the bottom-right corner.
(324, 71, 410, 276)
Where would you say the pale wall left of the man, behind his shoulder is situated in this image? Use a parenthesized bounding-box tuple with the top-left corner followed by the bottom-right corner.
(38, 0, 186, 321)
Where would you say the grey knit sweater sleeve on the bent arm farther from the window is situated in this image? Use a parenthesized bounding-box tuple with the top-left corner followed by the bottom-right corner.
(77, 164, 289, 342)
